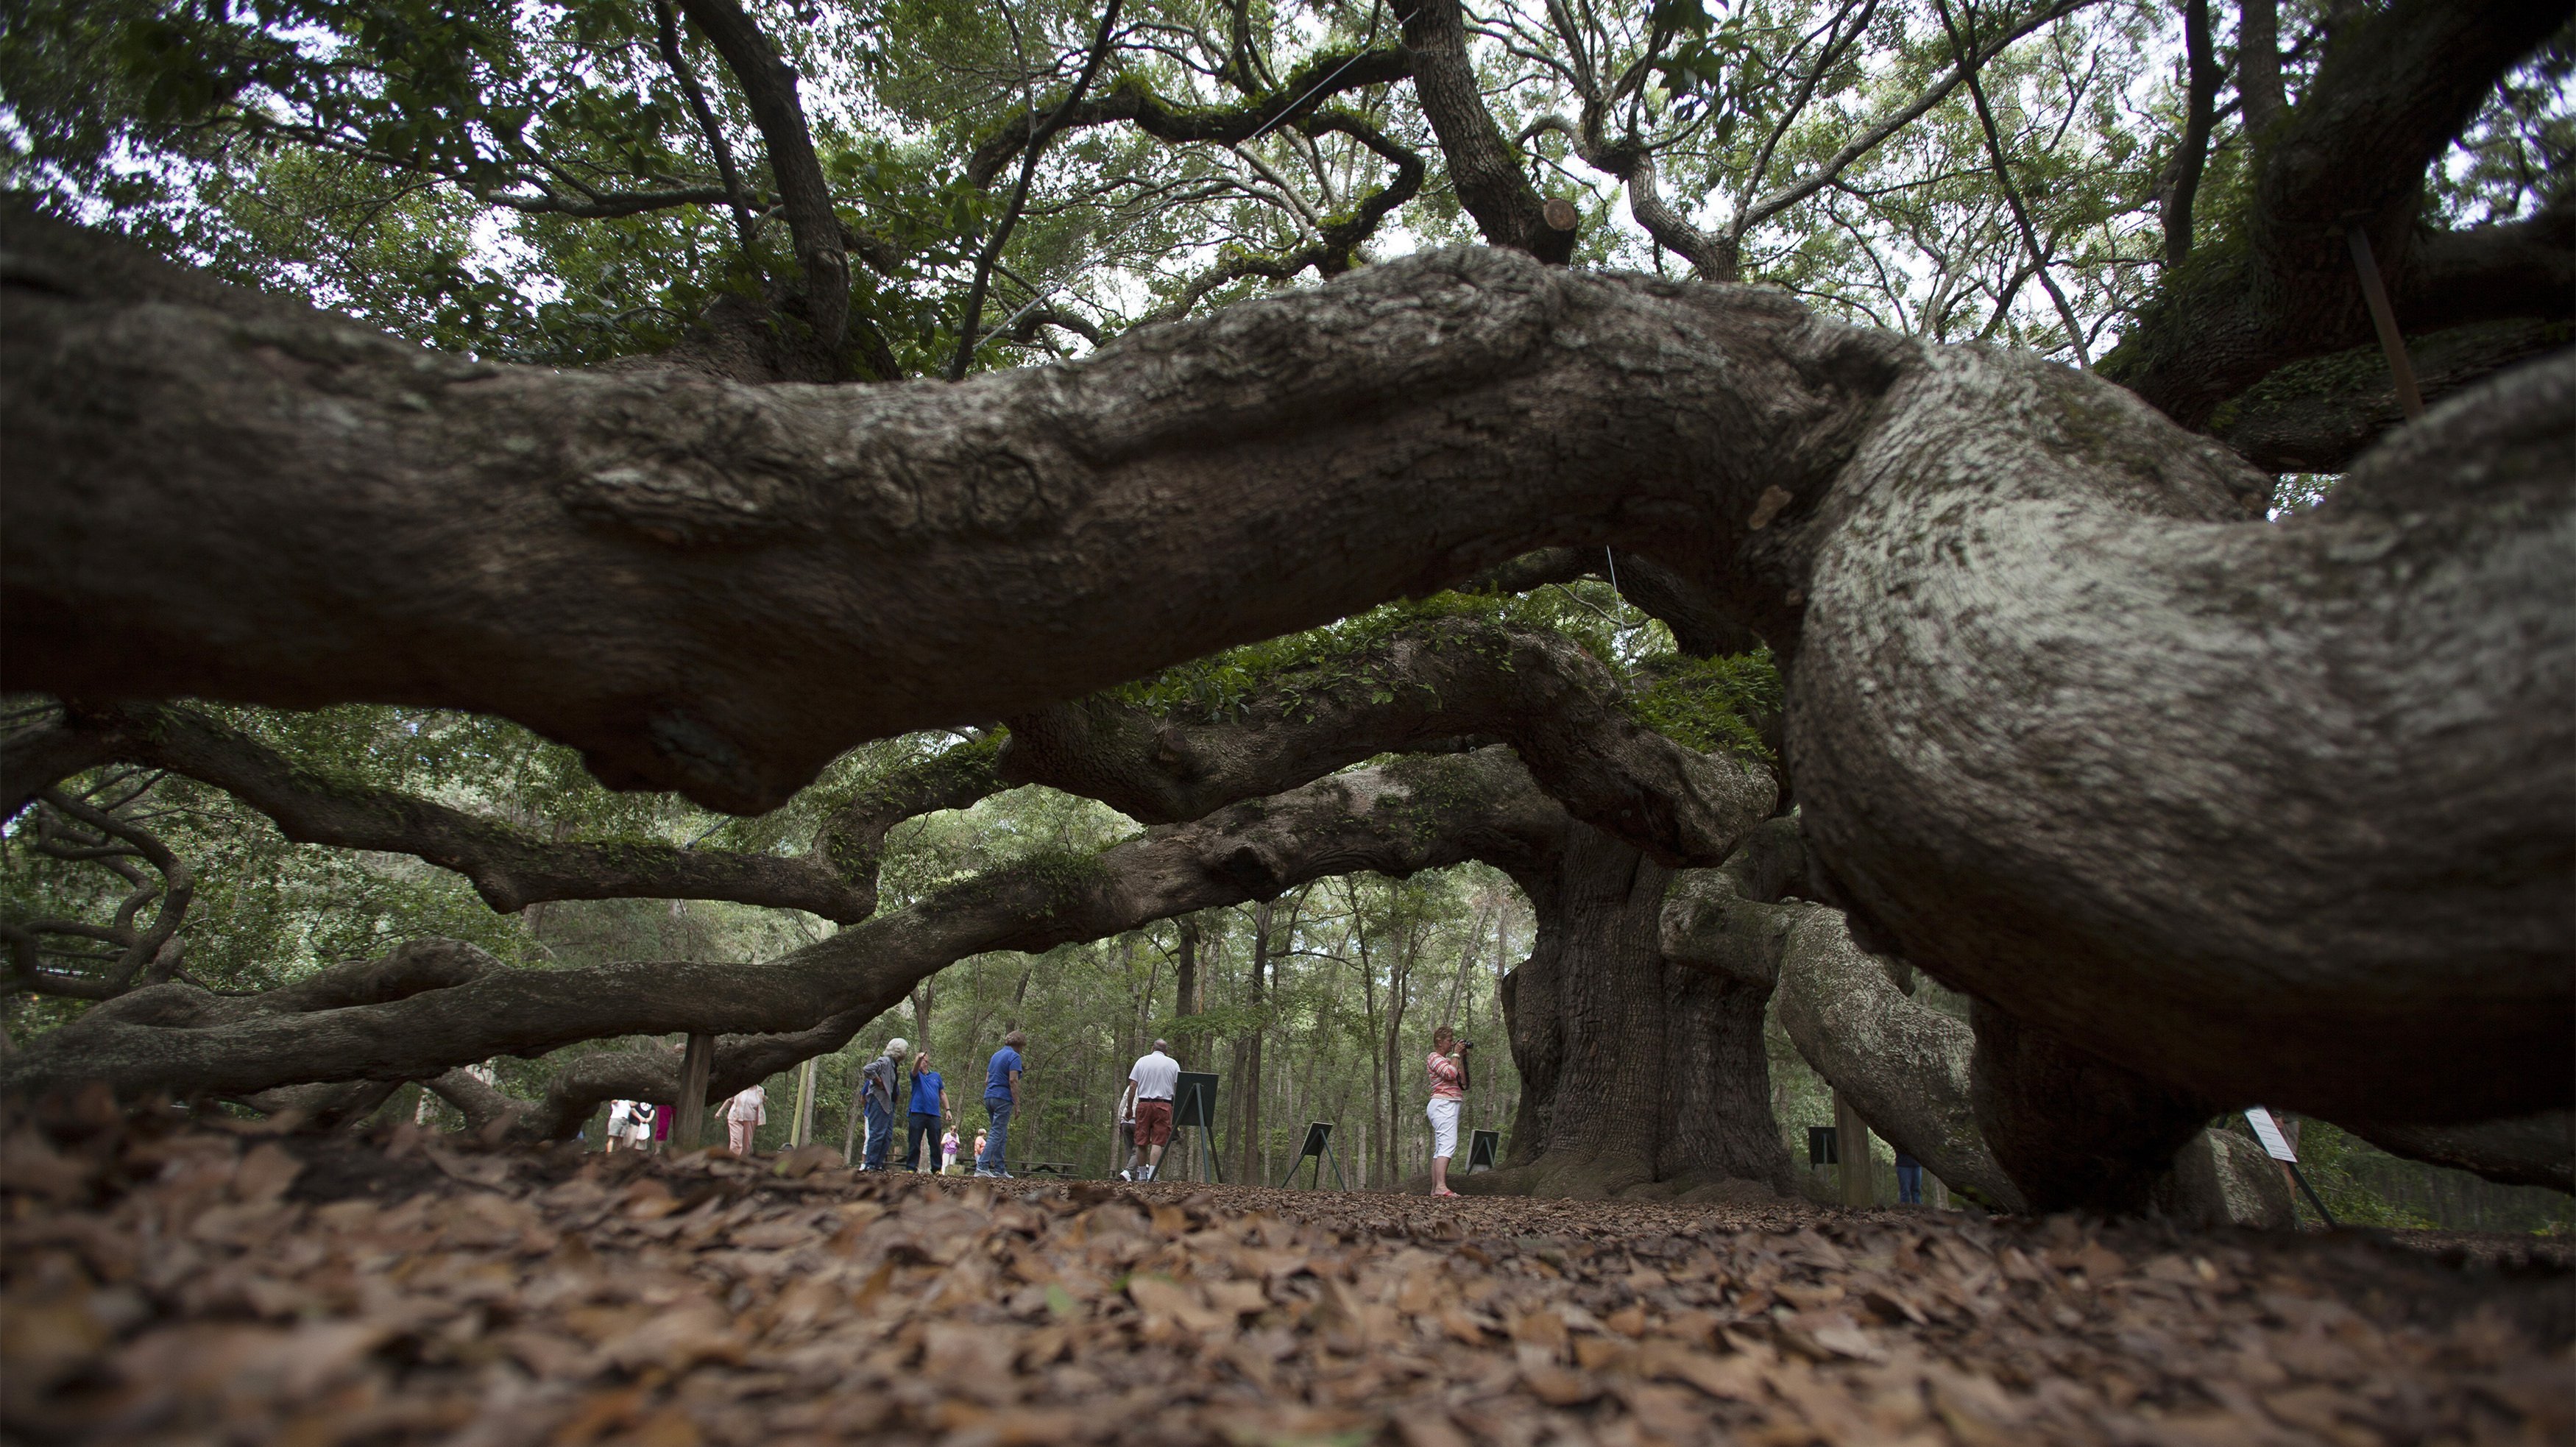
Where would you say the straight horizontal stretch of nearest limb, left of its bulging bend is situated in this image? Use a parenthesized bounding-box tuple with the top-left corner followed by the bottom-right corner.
(0, 211, 1875, 811)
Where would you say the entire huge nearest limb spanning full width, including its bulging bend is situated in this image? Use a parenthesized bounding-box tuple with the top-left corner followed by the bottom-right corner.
(0, 205, 2576, 1120)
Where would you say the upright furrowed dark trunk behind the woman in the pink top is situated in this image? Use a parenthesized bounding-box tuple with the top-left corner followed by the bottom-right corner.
(1451, 824, 1791, 1197)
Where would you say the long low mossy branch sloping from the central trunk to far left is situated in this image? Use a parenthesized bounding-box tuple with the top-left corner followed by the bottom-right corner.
(0, 749, 1566, 1097)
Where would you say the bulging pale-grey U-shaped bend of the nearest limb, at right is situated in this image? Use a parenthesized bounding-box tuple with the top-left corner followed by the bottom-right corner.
(1788, 342, 2576, 1122)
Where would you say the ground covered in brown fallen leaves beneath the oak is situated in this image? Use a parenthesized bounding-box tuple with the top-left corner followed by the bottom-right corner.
(0, 1102, 2576, 1447)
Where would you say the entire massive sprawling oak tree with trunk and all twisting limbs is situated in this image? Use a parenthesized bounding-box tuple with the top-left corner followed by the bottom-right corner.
(0, 0, 2576, 1208)
